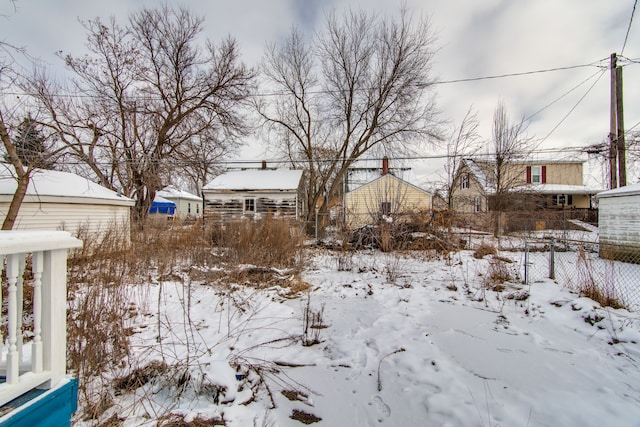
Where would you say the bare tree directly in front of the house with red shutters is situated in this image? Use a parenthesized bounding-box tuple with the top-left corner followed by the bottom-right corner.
(491, 102, 533, 236)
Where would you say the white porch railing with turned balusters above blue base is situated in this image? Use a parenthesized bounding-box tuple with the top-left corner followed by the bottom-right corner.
(0, 231, 82, 406)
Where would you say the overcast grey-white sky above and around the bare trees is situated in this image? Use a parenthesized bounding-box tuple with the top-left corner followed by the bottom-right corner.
(0, 0, 640, 186)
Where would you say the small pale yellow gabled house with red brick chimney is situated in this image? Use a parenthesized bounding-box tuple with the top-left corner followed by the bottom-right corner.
(345, 166, 432, 228)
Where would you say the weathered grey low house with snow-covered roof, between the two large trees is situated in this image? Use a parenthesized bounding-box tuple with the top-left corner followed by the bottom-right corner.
(202, 167, 304, 220)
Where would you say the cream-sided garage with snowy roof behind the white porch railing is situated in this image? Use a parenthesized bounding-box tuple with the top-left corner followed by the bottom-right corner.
(0, 168, 135, 238)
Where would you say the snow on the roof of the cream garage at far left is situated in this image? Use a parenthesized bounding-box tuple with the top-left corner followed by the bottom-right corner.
(0, 168, 133, 204)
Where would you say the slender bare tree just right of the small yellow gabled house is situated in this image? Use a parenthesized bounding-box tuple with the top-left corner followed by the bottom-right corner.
(444, 107, 480, 211)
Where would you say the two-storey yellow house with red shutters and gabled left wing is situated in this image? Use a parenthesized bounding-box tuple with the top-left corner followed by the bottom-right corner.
(452, 159, 600, 213)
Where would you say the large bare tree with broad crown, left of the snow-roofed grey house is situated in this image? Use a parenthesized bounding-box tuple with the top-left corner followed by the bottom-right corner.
(32, 6, 254, 219)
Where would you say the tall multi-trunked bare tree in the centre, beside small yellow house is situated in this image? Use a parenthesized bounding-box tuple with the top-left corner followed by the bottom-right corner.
(256, 10, 437, 231)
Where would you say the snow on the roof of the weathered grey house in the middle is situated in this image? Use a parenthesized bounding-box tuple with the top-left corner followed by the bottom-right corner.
(203, 169, 302, 190)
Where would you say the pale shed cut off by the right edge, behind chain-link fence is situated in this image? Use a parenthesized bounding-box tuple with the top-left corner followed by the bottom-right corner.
(597, 183, 640, 263)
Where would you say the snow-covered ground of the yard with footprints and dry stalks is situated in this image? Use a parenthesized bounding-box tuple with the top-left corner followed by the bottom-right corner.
(78, 247, 640, 427)
